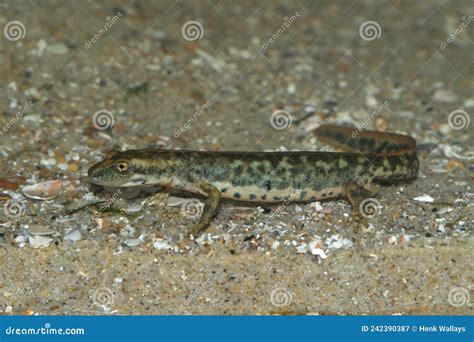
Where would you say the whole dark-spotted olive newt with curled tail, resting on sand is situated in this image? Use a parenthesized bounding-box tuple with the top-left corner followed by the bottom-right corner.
(88, 125, 419, 236)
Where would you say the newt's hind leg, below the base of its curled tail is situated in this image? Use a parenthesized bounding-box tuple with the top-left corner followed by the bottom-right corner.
(343, 181, 380, 233)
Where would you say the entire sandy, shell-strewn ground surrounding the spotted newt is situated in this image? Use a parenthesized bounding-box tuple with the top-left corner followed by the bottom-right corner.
(0, 0, 474, 315)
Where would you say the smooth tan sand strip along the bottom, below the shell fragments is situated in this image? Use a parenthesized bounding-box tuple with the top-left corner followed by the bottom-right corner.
(1, 238, 473, 315)
